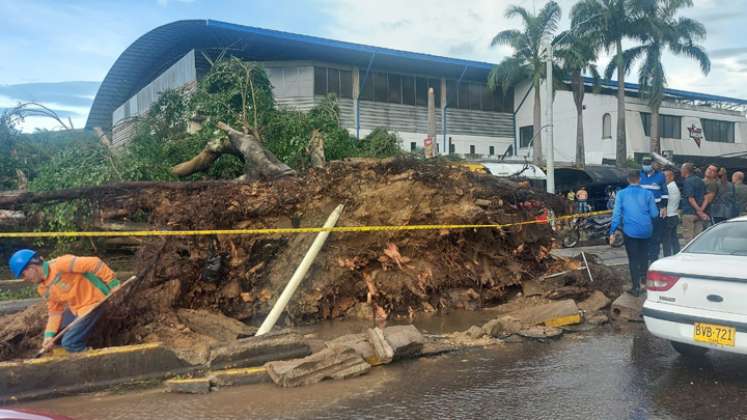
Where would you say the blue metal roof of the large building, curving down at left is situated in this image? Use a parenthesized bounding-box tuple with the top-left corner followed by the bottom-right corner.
(86, 20, 747, 130)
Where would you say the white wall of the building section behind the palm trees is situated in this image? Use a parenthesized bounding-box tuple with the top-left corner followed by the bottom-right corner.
(515, 83, 747, 164)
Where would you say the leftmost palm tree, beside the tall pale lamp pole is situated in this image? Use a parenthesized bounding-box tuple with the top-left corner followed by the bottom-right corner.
(488, 1, 560, 164)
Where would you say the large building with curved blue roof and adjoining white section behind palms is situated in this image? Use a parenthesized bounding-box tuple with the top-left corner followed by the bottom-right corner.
(86, 20, 747, 163)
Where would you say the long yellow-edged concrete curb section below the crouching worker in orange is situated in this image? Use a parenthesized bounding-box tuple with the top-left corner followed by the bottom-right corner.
(0, 343, 193, 404)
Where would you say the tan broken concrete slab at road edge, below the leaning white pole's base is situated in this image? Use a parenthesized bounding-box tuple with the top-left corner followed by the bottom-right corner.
(265, 347, 371, 387)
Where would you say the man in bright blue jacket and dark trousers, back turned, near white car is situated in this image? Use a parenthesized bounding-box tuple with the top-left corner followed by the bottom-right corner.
(610, 170, 659, 296)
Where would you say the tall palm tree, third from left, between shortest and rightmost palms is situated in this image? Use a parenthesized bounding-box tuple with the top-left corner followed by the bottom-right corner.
(571, 0, 643, 167)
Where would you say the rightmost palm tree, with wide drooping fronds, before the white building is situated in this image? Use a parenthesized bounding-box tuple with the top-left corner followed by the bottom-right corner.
(620, 0, 711, 153)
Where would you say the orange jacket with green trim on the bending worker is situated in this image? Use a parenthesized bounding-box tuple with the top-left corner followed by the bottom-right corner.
(37, 255, 119, 338)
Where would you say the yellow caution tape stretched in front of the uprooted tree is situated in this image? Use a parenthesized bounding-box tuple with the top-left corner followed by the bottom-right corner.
(0, 210, 611, 238)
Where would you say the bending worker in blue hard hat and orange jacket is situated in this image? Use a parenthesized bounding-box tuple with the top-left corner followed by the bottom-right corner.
(9, 249, 120, 353)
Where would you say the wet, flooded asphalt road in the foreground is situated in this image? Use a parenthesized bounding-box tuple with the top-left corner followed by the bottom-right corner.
(21, 325, 747, 419)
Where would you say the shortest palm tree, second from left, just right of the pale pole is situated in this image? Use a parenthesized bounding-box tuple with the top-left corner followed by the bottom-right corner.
(555, 31, 600, 169)
